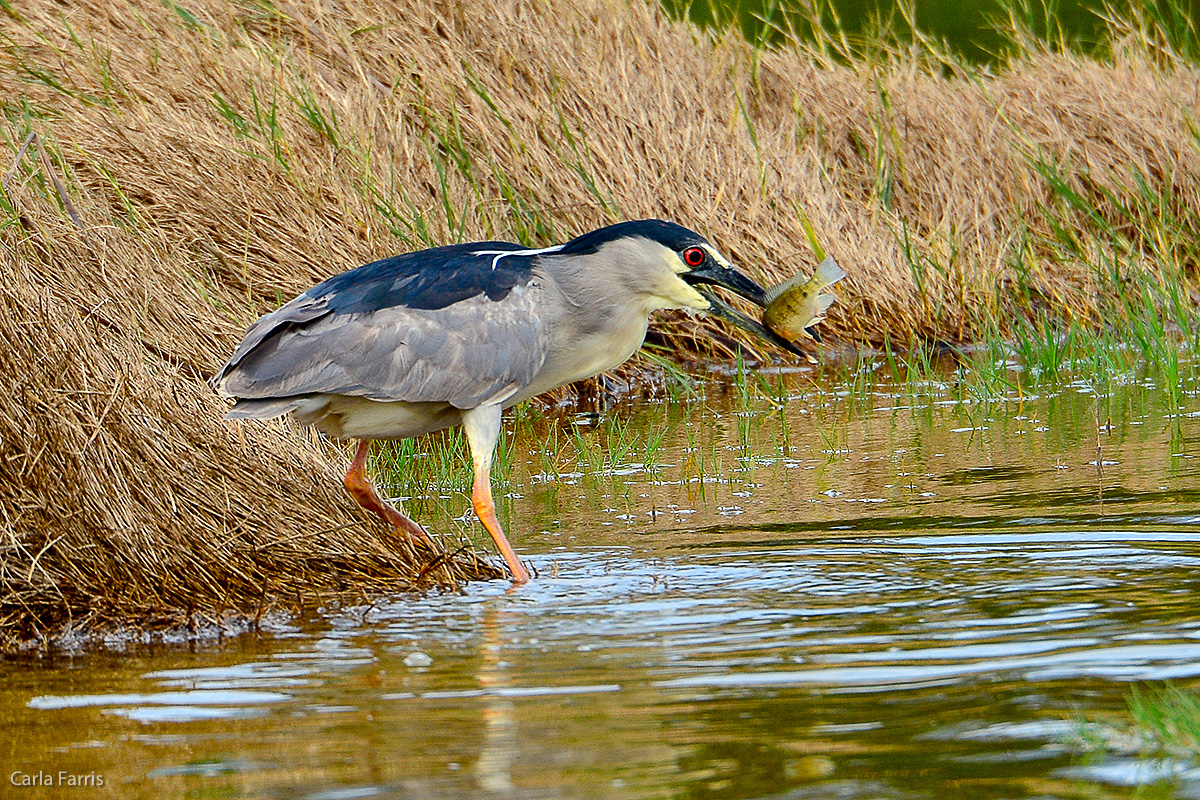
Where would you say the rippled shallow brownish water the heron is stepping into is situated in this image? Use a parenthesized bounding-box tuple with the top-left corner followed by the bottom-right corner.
(0, 364, 1200, 800)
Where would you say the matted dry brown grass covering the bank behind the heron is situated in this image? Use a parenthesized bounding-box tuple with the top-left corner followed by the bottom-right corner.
(0, 0, 1200, 645)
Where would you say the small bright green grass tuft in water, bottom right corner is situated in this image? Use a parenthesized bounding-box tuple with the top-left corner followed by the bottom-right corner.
(1076, 684, 1200, 758)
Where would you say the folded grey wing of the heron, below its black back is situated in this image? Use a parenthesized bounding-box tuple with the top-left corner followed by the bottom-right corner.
(218, 283, 550, 408)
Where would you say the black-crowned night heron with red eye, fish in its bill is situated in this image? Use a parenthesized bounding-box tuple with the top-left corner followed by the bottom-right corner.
(212, 219, 794, 583)
